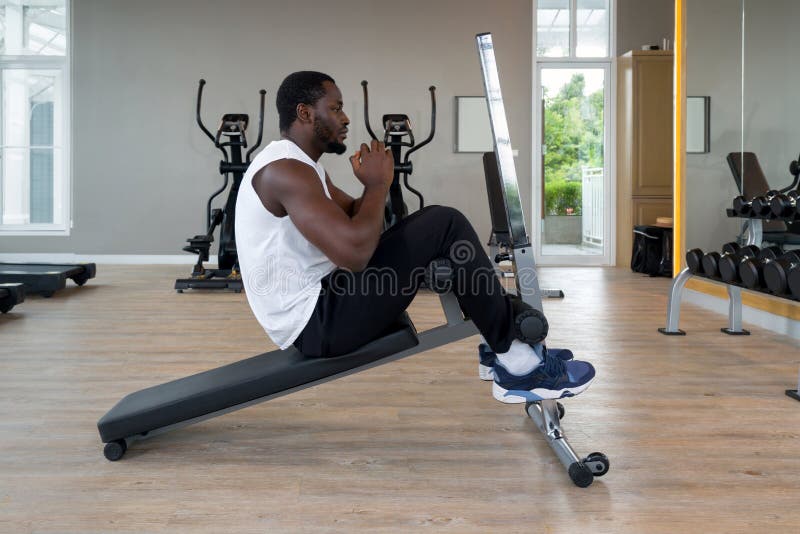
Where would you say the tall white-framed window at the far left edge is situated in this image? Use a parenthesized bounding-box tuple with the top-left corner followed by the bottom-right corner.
(0, 0, 70, 234)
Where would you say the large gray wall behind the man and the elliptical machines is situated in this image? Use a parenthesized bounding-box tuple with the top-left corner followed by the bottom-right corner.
(6, 0, 532, 259)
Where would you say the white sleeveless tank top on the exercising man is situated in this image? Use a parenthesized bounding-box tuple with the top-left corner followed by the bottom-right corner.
(235, 139, 336, 349)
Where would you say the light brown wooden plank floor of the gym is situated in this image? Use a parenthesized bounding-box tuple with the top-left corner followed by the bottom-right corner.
(0, 266, 800, 533)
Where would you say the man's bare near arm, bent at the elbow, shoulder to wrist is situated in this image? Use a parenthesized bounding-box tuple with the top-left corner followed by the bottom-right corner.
(253, 159, 388, 271)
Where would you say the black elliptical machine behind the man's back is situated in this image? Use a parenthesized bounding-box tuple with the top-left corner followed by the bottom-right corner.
(175, 79, 267, 293)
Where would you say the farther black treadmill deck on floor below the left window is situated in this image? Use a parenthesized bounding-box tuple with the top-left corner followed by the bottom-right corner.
(0, 263, 97, 297)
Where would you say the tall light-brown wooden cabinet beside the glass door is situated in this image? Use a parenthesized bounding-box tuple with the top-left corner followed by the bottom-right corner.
(617, 50, 673, 267)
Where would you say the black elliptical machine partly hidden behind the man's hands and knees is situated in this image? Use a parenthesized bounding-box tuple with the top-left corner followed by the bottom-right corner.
(361, 80, 436, 230)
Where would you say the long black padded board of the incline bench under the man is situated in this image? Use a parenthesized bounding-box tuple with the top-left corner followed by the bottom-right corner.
(97, 313, 419, 443)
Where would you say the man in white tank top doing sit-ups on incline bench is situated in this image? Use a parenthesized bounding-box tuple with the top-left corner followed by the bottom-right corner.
(236, 71, 594, 403)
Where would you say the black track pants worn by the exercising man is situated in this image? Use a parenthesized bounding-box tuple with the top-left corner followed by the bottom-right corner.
(294, 206, 514, 357)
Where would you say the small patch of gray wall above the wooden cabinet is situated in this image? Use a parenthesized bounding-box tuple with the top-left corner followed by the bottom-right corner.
(617, 0, 675, 55)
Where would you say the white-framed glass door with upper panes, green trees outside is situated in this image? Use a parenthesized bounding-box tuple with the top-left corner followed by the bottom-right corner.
(533, 0, 613, 265)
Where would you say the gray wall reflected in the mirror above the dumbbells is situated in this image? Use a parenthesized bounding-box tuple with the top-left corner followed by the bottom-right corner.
(686, 0, 800, 254)
